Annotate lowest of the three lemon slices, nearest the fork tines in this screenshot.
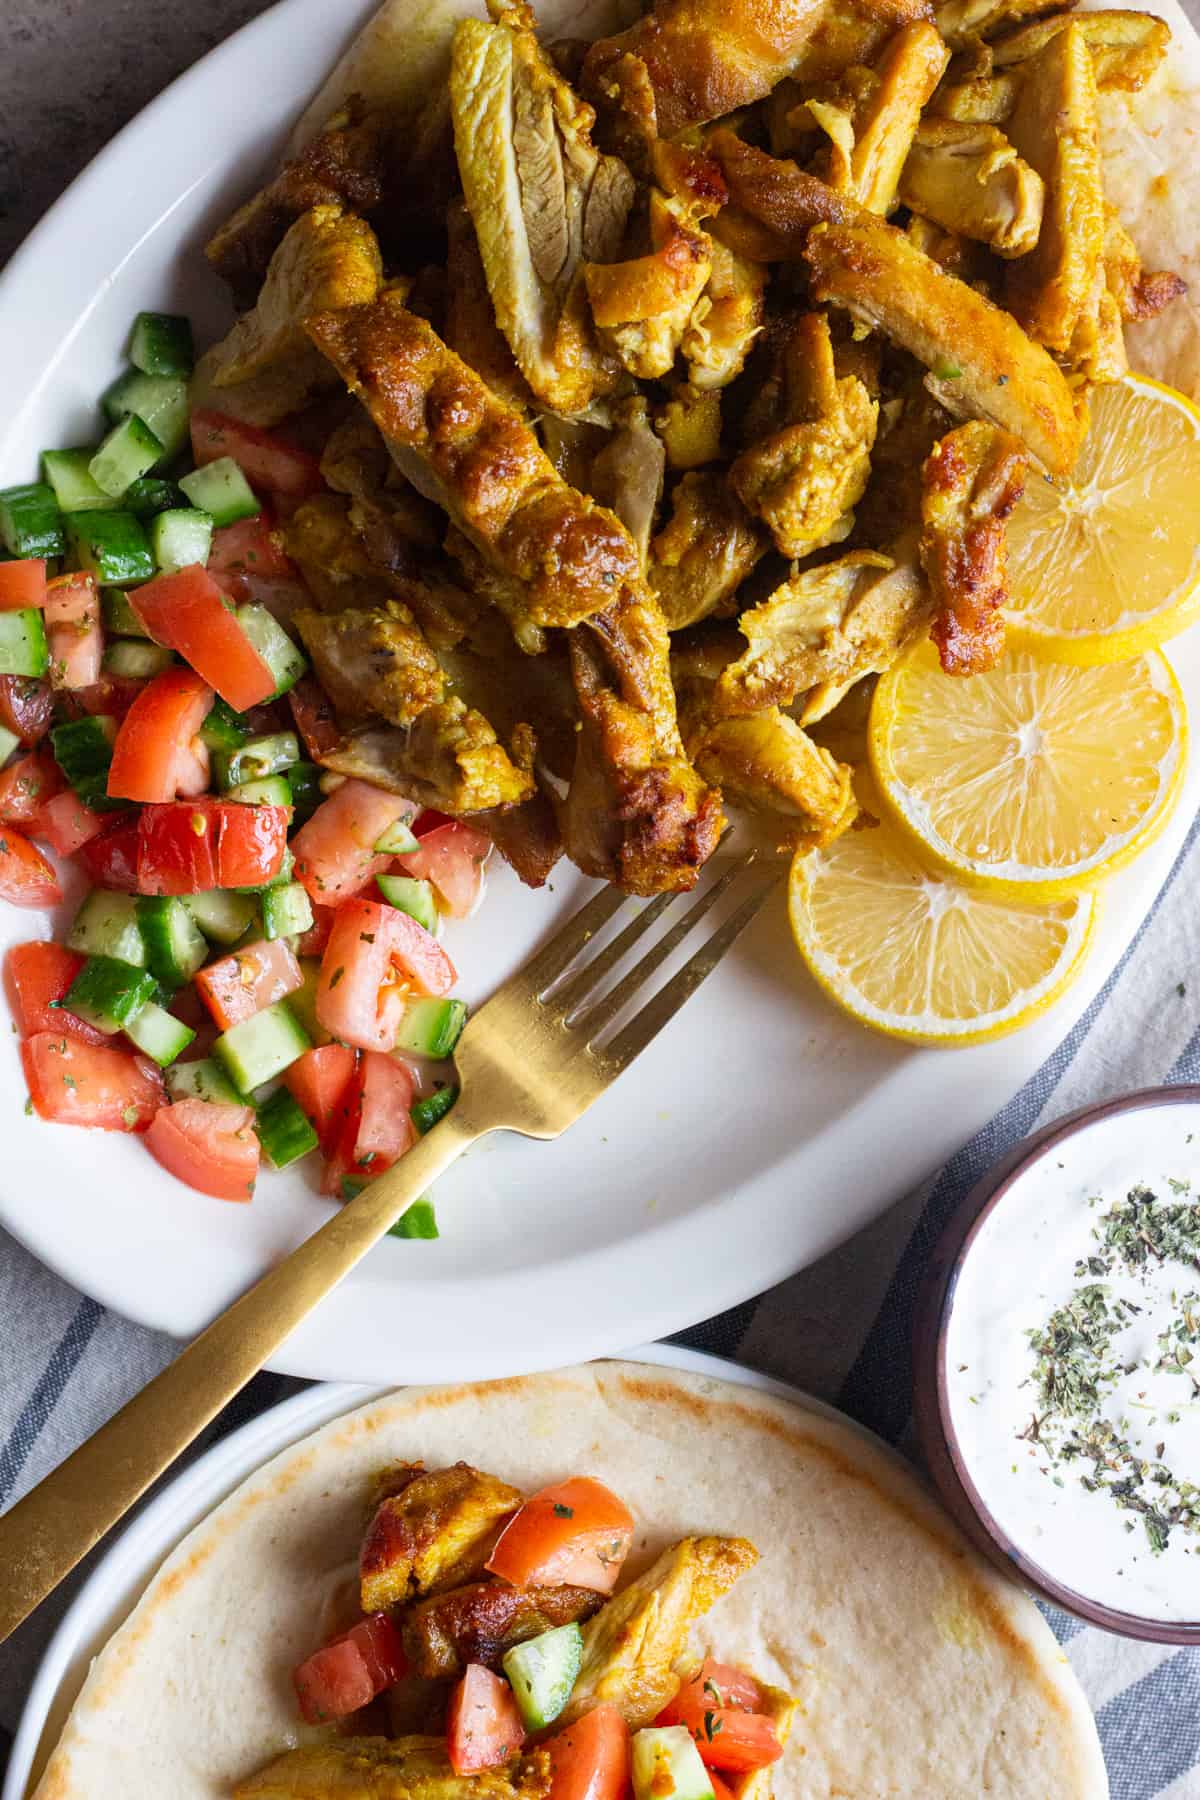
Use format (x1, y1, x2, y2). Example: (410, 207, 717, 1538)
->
(788, 823, 1096, 1044)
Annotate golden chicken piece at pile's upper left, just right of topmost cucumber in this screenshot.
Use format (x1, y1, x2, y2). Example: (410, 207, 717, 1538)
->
(193, 205, 383, 425)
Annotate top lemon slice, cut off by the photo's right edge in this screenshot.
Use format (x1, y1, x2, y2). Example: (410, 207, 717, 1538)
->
(1006, 374, 1200, 664)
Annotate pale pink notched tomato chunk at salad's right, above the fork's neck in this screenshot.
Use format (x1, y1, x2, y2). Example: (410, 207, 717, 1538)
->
(317, 900, 457, 1051)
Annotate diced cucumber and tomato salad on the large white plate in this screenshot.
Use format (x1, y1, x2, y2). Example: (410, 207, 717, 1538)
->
(0, 313, 491, 1237)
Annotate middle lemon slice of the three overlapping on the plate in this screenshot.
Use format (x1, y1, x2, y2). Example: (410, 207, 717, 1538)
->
(869, 641, 1187, 900)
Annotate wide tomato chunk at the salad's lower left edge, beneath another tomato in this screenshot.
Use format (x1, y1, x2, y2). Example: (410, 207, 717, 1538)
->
(22, 1030, 164, 1130)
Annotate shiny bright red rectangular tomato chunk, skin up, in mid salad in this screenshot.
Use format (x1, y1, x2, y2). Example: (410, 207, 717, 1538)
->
(137, 797, 290, 895)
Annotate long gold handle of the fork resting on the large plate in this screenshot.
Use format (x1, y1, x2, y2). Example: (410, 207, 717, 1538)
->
(0, 1100, 482, 1642)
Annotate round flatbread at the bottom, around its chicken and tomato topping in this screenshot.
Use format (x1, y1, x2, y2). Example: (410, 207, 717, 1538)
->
(36, 1363, 1108, 1800)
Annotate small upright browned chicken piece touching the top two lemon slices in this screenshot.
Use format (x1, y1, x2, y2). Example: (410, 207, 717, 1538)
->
(921, 419, 1025, 675)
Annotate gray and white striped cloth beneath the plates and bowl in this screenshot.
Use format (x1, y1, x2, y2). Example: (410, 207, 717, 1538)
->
(0, 821, 1200, 1800)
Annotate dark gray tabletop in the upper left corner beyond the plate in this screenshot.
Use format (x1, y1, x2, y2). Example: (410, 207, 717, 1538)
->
(0, 0, 270, 265)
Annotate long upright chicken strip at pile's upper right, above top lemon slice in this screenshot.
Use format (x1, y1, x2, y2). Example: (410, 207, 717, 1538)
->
(1004, 23, 1105, 351)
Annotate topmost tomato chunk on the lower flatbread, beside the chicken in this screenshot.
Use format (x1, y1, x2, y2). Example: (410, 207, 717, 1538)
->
(488, 1474, 633, 1593)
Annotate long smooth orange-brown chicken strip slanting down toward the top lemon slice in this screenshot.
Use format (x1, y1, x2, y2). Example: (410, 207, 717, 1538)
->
(804, 214, 1083, 475)
